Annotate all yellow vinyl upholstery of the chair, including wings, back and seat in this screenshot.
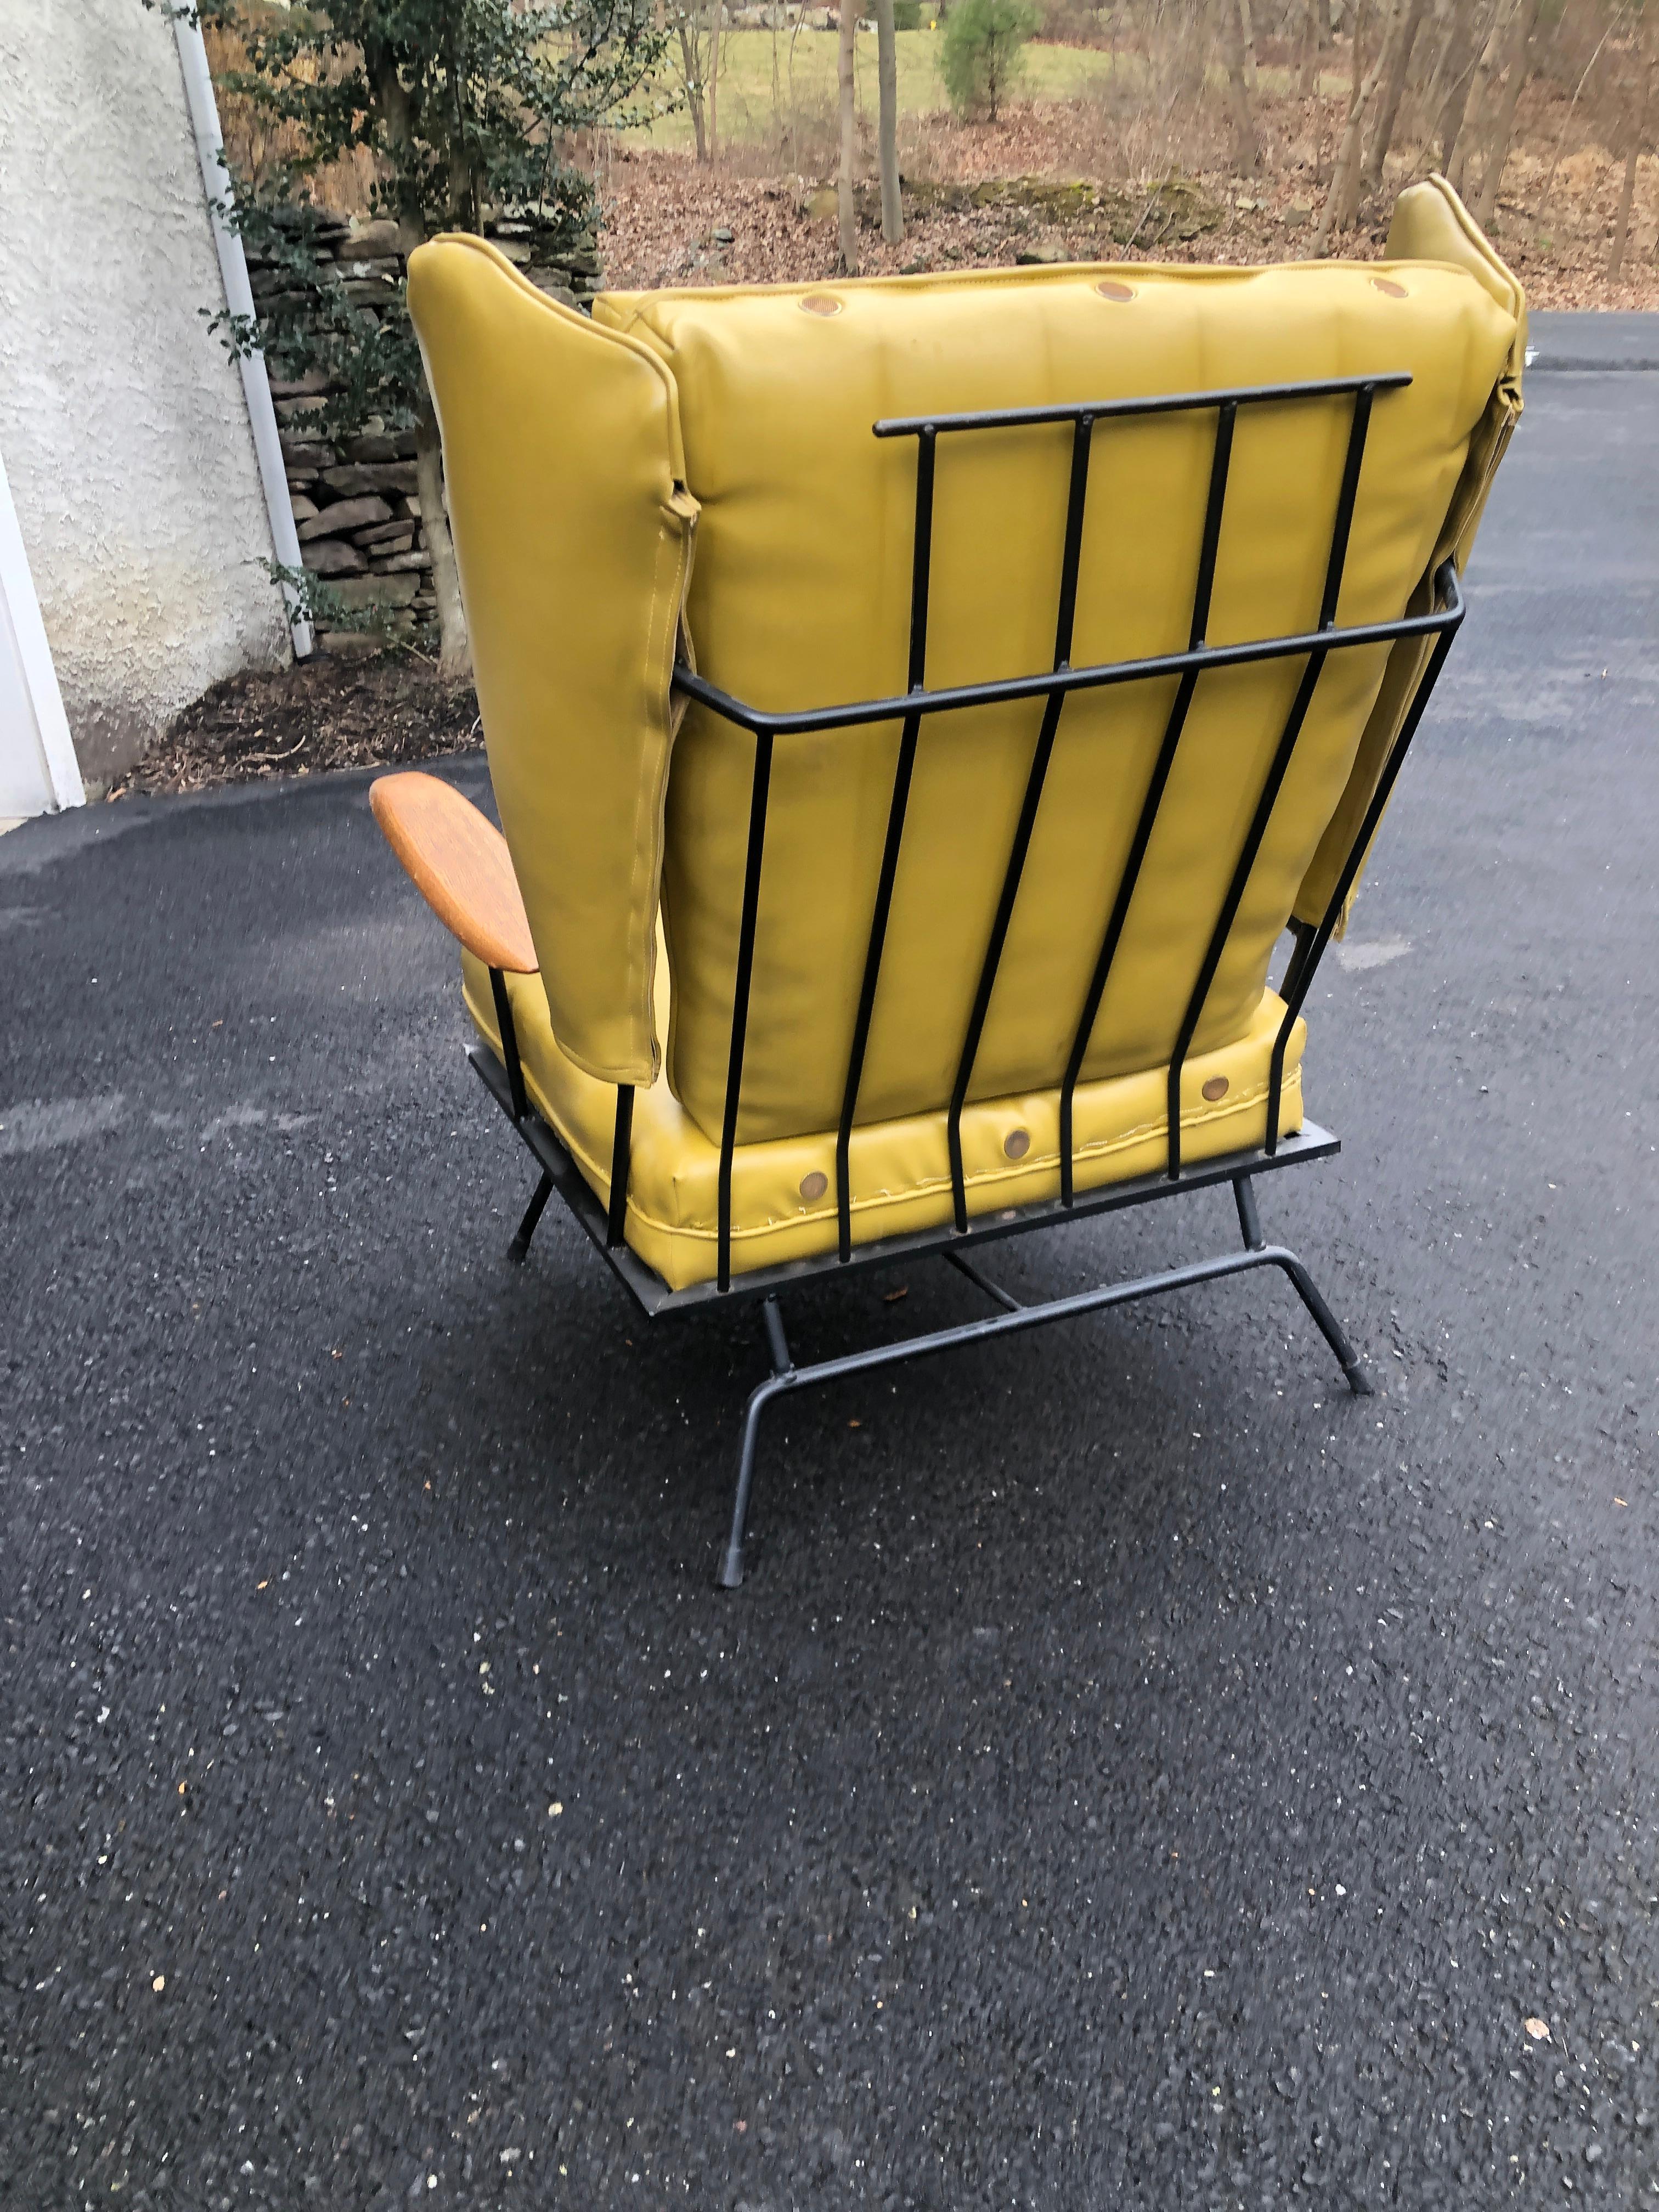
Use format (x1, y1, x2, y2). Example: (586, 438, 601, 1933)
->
(409, 184, 1524, 1288)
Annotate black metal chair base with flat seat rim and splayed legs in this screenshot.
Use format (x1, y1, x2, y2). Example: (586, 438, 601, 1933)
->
(467, 1044, 1372, 1590)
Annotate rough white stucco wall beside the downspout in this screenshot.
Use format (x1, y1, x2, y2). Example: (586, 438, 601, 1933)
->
(0, 0, 290, 778)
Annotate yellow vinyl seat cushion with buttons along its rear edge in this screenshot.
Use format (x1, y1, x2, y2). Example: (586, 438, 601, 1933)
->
(460, 953, 1305, 1290)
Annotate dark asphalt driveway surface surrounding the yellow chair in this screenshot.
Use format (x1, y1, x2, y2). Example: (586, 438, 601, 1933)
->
(0, 354, 1659, 2212)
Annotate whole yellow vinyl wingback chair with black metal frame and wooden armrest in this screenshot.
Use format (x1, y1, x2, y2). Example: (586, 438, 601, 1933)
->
(374, 179, 1526, 1586)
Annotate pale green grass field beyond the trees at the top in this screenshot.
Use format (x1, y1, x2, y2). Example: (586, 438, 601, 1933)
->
(630, 31, 1113, 150)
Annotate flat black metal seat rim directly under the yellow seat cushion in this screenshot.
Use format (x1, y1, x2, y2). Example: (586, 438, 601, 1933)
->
(467, 1042, 1342, 1321)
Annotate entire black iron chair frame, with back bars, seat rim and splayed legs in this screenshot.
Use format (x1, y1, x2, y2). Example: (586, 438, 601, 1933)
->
(469, 371, 1464, 1588)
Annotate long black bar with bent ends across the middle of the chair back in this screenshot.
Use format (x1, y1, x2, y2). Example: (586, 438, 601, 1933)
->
(675, 589, 1464, 737)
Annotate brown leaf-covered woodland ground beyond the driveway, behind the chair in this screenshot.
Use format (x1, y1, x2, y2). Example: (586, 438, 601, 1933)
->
(595, 50, 1659, 307)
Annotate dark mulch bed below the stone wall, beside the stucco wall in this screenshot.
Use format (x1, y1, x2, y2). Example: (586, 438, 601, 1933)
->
(111, 652, 480, 799)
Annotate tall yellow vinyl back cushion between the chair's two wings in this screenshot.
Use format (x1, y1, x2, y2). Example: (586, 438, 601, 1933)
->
(595, 211, 1517, 1142)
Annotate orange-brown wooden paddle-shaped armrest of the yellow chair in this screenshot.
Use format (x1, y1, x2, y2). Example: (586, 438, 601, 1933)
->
(369, 770, 538, 975)
